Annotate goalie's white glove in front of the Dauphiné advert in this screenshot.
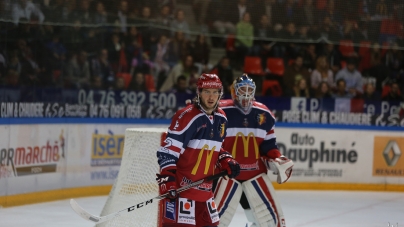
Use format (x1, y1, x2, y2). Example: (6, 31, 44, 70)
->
(261, 155, 294, 184)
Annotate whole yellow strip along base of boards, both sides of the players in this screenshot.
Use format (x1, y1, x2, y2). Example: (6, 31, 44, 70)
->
(0, 182, 404, 207)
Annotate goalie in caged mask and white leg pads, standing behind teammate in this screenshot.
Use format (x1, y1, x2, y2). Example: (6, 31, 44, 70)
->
(214, 74, 293, 227)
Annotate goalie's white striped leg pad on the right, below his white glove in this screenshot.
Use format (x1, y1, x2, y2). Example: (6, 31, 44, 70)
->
(242, 173, 286, 227)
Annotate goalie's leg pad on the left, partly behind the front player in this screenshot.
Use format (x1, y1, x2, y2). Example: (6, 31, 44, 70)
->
(214, 178, 243, 227)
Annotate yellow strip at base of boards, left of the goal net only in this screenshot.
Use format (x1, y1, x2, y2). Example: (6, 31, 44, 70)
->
(0, 185, 112, 207)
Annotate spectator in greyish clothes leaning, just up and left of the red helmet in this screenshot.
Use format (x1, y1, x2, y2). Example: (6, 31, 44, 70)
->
(159, 55, 198, 92)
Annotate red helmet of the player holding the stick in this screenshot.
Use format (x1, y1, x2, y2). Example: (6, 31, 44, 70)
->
(195, 73, 223, 112)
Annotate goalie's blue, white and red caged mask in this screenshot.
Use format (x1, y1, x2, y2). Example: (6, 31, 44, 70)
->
(231, 73, 256, 114)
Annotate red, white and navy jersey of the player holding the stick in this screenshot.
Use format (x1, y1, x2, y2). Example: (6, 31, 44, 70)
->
(157, 105, 227, 201)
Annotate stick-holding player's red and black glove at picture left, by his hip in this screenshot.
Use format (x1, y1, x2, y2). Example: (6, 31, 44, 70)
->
(156, 170, 179, 199)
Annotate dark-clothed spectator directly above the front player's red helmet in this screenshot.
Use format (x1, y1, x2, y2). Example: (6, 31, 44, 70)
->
(191, 34, 210, 74)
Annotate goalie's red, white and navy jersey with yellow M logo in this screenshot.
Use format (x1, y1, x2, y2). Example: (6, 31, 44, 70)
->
(219, 100, 280, 180)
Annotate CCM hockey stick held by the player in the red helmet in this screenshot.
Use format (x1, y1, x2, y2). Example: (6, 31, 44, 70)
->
(70, 171, 227, 223)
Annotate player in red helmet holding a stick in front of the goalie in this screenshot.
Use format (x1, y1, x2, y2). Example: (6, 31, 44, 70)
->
(156, 74, 240, 227)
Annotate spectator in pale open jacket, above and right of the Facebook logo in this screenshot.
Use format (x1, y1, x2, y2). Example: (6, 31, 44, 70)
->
(311, 55, 335, 90)
